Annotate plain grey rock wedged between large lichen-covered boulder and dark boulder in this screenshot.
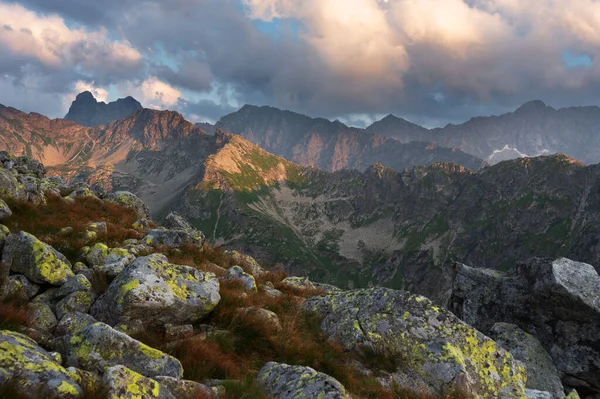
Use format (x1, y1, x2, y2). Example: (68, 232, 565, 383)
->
(490, 323, 565, 399)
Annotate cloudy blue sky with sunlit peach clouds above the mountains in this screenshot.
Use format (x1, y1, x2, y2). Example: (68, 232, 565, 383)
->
(0, 0, 600, 127)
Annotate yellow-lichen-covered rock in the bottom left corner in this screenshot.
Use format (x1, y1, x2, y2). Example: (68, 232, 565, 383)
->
(0, 331, 83, 399)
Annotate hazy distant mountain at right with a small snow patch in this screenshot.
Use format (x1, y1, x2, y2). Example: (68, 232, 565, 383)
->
(366, 101, 600, 164)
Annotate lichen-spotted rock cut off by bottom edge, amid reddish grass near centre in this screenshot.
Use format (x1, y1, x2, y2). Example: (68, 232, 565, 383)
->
(256, 362, 350, 399)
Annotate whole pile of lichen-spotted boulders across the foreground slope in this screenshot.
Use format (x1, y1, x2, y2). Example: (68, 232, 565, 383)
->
(0, 153, 600, 399)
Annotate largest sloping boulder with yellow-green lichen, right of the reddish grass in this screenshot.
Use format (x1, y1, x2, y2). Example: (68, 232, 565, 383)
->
(303, 288, 527, 398)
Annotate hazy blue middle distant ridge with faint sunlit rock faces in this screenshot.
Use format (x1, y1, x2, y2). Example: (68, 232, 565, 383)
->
(216, 105, 484, 171)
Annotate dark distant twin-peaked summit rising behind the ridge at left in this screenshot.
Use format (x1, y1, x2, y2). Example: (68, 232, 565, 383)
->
(65, 91, 143, 127)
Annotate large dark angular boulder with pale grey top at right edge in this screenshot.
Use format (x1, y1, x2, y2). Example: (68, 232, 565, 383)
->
(449, 258, 600, 395)
